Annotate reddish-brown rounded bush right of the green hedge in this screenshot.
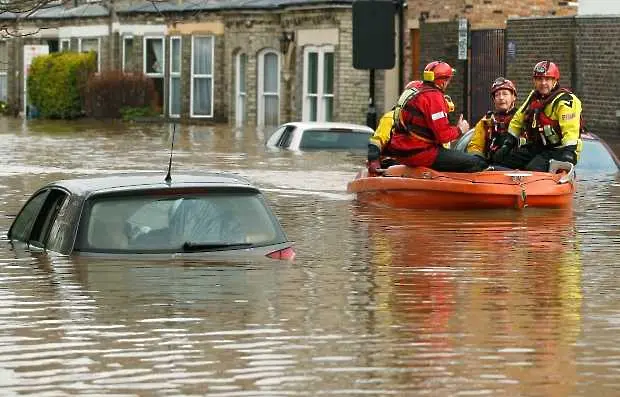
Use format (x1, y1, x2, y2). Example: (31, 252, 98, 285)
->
(84, 70, 157, 119)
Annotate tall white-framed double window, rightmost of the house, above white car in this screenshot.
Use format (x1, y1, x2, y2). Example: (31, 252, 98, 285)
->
(302, 46, 334, 121)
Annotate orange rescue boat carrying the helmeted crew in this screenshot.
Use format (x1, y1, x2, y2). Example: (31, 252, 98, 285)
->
(347, 161, 575, 209)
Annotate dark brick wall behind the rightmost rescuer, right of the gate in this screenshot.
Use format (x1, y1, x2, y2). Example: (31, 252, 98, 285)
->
(506, 17, 620, 135)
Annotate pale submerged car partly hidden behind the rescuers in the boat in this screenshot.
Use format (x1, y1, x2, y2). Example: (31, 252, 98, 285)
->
(453, 129, 620, 173)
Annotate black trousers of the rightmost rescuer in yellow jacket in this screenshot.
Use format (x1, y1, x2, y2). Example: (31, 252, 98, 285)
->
(495, 145, 577, 172)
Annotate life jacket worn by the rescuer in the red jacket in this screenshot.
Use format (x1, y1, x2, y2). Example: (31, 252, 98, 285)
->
(393, 83, 440, 143)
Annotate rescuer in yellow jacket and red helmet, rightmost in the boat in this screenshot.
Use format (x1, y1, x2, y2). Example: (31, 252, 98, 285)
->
(494, 61, 584, 171)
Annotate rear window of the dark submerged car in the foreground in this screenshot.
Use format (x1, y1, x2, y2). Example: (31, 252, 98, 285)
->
(75, 192, 286, 253)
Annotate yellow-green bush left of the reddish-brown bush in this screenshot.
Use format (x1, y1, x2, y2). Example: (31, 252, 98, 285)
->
(28, 52, 97, 119)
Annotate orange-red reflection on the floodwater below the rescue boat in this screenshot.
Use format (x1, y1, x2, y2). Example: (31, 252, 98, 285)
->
(355, 207, 582, 396)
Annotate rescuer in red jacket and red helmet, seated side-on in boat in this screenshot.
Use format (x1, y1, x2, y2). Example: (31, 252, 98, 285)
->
(368, 61, 487, 172)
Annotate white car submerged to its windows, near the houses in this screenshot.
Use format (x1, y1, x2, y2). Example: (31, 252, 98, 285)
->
(266, 121, 374, 151)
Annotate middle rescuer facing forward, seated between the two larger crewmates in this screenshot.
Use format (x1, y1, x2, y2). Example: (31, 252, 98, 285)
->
(467, 77, 517, 162)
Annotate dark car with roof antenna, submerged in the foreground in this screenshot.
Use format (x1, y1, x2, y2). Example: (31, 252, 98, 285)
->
(7, 173, 295, 259)
